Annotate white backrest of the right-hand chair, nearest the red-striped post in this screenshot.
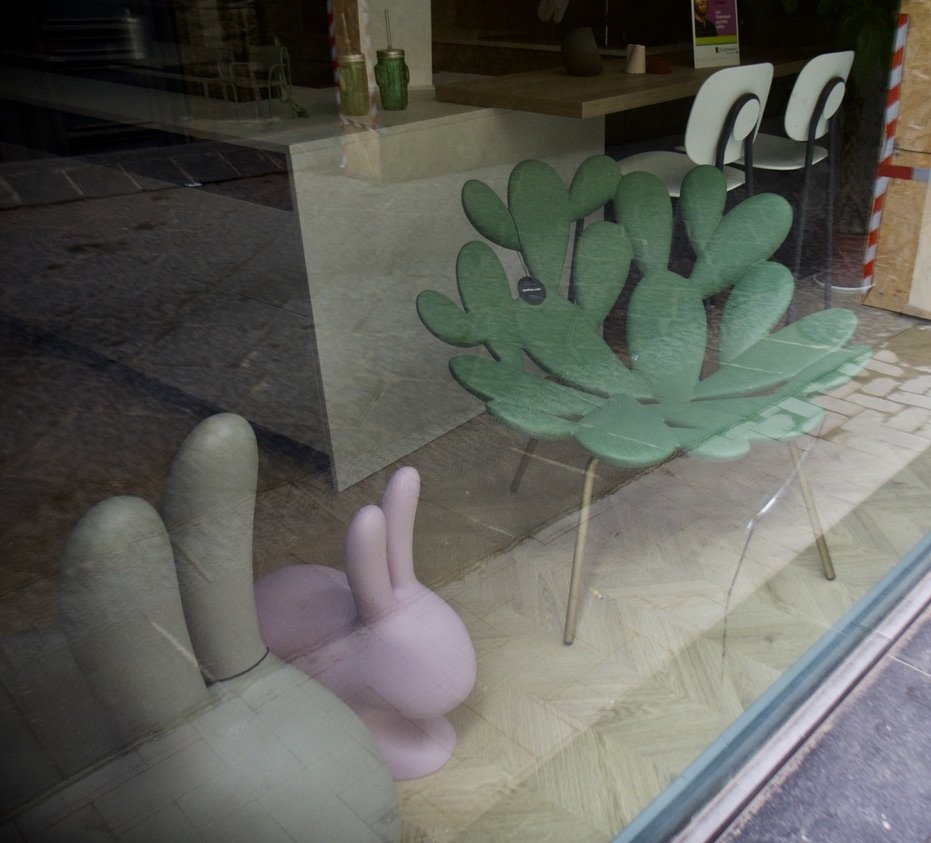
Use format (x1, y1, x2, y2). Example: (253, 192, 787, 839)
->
(785, 50, 853, 141)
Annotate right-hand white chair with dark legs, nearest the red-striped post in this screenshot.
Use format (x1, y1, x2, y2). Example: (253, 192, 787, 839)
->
(747, 50, 853, 306)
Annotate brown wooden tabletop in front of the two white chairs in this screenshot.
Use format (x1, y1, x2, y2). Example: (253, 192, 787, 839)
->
(436, 51, 810, 118)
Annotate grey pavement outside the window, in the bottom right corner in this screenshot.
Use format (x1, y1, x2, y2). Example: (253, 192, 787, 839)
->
(718, 592, 931, 843)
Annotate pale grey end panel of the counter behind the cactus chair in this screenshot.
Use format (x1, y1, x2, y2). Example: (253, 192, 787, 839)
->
(288, 91, 604, 489)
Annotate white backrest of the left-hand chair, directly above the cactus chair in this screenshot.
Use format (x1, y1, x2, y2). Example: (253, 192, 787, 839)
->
(685, 62, 773, 165)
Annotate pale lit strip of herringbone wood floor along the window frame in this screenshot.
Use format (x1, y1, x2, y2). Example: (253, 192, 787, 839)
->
(399, 318, 931, 843)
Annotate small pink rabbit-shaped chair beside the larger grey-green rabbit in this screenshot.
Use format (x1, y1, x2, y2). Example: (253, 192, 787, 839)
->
(255, 468, 475, 779)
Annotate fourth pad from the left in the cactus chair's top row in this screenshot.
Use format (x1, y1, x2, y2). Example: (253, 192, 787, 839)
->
(614, 173, 672, 275)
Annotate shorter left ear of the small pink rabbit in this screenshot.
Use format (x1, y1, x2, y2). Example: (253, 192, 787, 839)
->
(344, 505, 395, 623)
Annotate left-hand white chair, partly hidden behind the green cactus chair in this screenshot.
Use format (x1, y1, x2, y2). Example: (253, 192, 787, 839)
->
(618, 62, 773, 197)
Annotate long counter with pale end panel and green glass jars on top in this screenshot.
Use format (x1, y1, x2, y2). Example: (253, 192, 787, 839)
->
(0, 62, 604, 489)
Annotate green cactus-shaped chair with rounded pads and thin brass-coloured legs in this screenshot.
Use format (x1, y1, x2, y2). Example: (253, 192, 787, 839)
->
(417, 155, 870, 644)
